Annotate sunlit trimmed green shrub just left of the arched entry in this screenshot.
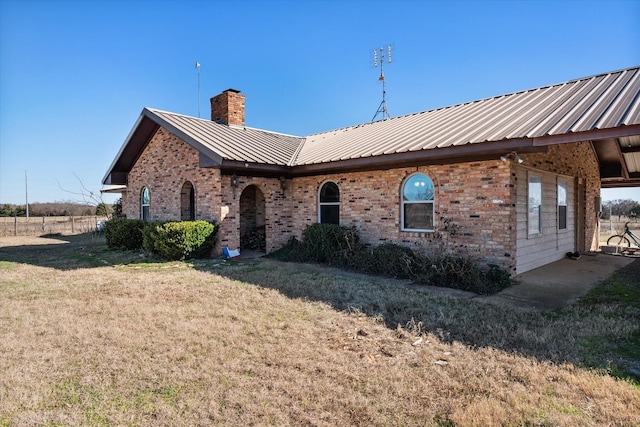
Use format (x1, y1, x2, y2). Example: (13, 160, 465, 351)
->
(143, 221, 218, 260)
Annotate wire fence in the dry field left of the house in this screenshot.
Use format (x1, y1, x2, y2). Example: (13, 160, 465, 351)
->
(0, 215, 107, 237)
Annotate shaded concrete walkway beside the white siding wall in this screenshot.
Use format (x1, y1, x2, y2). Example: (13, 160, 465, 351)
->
(475, 252, 637, 311)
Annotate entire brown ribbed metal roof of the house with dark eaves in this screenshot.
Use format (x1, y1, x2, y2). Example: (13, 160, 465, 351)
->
(103, 67, 640, 187)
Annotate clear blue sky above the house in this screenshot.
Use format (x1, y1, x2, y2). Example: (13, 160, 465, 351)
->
(0, 0, 640, 204)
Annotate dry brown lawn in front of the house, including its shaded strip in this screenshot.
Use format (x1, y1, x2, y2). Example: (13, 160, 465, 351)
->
(0, 237, 640, 426)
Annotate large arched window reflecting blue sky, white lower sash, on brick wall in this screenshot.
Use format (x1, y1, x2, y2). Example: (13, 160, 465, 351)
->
(401, 173, 434, 231)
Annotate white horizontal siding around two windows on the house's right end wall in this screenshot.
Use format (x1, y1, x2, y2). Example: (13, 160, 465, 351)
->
(516, 167, 575, 274)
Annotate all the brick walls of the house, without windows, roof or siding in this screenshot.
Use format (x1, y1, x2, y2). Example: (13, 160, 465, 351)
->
(123, 128, 600, 271)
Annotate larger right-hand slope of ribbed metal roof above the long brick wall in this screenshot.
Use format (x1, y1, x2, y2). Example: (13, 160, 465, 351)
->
(295, 67, 640, 165)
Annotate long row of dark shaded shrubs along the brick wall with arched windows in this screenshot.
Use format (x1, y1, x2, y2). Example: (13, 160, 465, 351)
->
(269, 224, 513, 295)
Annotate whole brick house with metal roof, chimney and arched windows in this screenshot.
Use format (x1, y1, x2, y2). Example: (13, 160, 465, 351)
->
(103, 67, 640, 275)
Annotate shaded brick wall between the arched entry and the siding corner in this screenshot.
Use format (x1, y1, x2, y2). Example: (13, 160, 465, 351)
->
(278, 161, 515, 267)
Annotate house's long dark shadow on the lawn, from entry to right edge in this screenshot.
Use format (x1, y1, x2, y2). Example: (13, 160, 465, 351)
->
(202, 254, 640, 385)
